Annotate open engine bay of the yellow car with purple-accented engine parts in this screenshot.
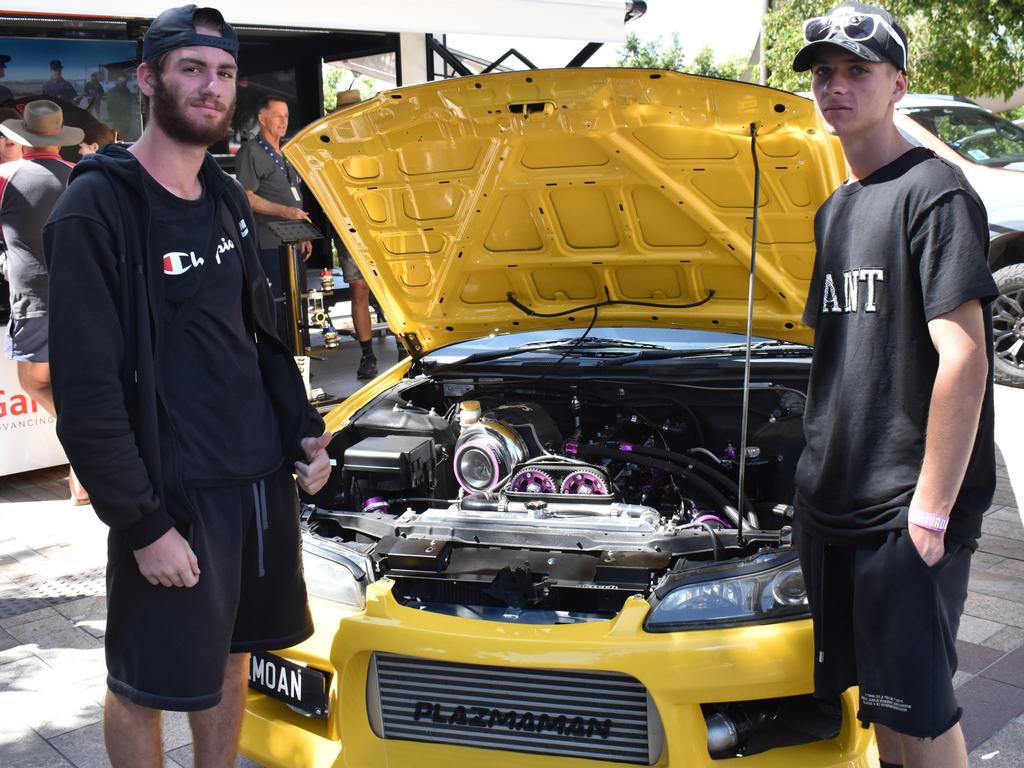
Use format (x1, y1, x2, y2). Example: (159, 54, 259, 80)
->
(306, 366, 806, 623)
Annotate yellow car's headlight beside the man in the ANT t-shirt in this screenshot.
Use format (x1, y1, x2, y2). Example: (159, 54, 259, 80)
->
(644, 551, 810, 632)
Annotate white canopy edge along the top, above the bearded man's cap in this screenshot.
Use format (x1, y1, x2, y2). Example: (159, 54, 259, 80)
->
(3, 0, 626, 42)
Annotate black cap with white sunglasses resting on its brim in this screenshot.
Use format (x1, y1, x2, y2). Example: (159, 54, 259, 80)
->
(793, 3, 906, 72)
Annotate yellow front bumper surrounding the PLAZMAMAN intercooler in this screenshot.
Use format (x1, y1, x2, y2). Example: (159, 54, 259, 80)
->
(242, 580, 874, 768)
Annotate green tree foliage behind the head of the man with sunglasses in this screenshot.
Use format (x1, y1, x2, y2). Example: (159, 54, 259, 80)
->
(764, 0, 1024, 96)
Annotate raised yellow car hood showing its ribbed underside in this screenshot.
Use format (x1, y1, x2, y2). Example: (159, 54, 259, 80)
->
(285, 69, 844, 354)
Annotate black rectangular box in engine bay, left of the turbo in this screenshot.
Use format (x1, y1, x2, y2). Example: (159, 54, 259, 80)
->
(344, 435, 434, 490)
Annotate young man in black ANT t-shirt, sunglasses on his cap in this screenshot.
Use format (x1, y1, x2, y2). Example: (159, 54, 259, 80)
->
(794, 3, 996, 768)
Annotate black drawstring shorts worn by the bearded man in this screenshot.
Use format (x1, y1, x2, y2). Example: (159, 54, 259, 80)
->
(105, 466, 312, 712)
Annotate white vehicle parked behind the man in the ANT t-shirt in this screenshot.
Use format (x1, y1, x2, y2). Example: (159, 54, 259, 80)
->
(896, 94, 1024, 387)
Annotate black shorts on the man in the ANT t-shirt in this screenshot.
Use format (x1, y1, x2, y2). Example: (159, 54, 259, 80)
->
(796, 528, 972, 738)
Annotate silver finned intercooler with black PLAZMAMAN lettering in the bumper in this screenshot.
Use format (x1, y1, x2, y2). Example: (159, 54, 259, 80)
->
(367, 653, 664, 765)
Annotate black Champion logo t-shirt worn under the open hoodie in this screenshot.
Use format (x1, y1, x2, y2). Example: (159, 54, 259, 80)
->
(143, 174, 283, 486)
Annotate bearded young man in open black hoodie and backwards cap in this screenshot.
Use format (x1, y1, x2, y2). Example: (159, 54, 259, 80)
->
(45, 5, 331, 768)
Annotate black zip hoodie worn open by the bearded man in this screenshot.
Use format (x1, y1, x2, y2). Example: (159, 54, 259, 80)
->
(43, 144, 324, 549)
